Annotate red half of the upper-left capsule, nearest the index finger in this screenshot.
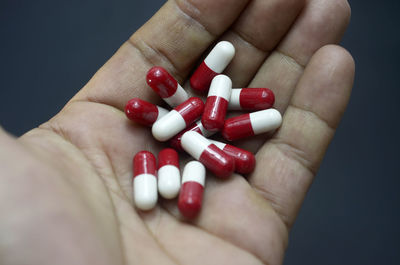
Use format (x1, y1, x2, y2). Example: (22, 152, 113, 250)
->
(146, 66, 178, 98)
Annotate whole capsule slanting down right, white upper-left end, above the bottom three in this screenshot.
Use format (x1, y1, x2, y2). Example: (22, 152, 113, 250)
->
(181, 131, 235, 178)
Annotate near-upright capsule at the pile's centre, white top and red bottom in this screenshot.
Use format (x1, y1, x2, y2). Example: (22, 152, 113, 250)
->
(201, 75, 232, 132)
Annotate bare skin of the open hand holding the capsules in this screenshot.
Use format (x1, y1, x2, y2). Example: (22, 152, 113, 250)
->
(0, 0, 354, 265)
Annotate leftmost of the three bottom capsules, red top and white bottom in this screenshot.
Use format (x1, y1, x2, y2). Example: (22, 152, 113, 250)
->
(133, 151, 158, 211)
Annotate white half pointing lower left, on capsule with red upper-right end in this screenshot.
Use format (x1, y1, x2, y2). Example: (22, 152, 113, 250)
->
(151, 110, 186, 142)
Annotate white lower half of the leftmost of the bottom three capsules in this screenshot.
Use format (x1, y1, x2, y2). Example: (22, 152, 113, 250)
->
(133, 174, 158, 211)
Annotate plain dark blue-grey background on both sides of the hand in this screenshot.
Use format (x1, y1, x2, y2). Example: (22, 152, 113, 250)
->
(0, 0, 400, 265)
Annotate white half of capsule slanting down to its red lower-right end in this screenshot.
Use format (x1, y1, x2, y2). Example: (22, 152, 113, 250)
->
(181, 131, 211, 160)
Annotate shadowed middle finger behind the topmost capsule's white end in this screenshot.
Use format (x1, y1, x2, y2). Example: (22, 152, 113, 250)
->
(221, 0, 304, 87)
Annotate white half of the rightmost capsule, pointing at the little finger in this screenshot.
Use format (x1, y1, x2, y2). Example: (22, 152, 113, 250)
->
(250, 109, 282, 135)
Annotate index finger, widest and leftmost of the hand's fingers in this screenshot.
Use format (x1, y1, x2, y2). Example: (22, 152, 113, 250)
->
(74, 0, 248, 109)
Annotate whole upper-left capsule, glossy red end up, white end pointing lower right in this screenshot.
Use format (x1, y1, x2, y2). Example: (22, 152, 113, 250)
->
(146, 66, 189, 108)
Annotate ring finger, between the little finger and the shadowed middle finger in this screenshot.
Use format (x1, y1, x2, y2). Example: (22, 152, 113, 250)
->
(250, 0, 350, 112)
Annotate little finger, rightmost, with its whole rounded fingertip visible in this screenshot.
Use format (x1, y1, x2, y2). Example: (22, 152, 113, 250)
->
(249, 45, 354, 227)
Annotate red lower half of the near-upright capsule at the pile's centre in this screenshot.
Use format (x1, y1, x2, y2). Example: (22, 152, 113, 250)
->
(201, 96, 228, 132)
